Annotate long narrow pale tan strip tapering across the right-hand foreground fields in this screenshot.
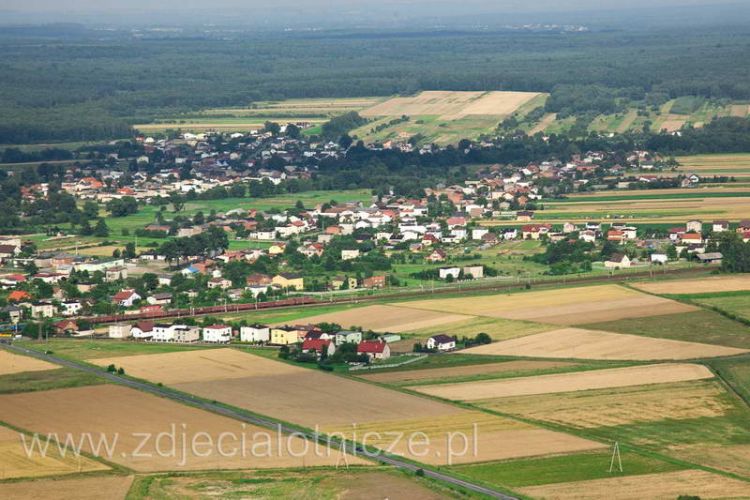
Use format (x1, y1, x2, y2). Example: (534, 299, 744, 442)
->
(413, 363, 714, 401)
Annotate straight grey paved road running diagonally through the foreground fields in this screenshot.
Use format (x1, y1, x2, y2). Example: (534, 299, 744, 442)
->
(0, 344, 517, 500)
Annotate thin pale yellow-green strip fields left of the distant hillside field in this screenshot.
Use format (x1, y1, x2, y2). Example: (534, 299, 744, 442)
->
(135, 97, 384, 133)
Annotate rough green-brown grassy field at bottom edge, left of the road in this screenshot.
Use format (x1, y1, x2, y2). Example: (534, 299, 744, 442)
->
(131, 468, 460, 500)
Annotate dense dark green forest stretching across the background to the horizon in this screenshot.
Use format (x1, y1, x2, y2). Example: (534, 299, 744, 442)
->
(0, 27, 750, 144)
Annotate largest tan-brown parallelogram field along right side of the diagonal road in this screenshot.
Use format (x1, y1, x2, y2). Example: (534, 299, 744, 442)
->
(91, 349, 602, 464)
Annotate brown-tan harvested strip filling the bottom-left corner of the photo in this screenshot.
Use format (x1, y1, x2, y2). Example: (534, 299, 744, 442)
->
(0, 476, 133, 500)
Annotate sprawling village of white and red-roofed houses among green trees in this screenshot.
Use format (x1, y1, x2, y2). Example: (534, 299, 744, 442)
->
(0, 129, 750, 346)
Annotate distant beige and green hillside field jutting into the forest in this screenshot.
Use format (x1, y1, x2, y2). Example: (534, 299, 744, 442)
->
(350, 91, 547, 145)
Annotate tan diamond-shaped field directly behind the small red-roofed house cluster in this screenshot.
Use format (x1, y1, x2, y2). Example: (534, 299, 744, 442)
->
(280, 306, 471, 333)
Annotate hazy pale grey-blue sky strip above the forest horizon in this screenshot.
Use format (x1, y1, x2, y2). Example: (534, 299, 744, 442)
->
(0, 0, 750, 26)
